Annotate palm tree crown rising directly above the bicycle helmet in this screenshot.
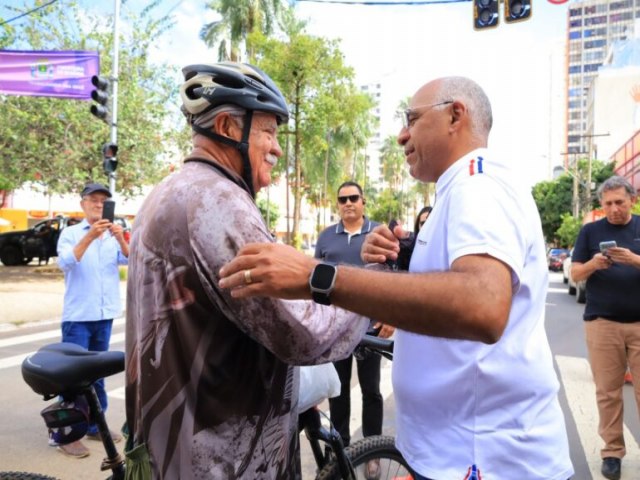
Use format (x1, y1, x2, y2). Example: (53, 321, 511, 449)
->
(200, 0, 289, 61)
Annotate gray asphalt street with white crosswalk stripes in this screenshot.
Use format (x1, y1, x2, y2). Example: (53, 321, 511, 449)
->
(0, 272, 640, 480)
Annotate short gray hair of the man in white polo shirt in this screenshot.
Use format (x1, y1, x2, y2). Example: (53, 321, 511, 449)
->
(438, 77, 493, 140)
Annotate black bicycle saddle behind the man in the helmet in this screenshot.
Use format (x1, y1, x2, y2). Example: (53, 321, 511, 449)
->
(22, 343, 124, 397)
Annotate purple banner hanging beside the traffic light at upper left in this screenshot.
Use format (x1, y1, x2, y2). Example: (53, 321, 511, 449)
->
(0, 50, 100, 100)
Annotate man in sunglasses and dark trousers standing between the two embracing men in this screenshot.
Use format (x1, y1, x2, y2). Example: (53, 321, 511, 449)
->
(315, 181, 393, 478)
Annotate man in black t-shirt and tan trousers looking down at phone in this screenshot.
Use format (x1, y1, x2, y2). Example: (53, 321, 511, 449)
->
(571, 176, 640, 480)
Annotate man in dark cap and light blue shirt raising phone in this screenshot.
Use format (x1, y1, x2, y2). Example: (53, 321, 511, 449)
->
(49, 183, 129, 458)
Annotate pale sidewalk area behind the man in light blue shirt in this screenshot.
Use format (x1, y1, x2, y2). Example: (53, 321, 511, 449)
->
(0, 263, 126, 332)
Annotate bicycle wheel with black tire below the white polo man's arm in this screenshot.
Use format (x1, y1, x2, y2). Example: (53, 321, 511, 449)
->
(316, 435, 412, 480)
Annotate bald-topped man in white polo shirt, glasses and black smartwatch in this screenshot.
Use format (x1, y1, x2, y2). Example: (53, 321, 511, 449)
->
(221, 77, 573, 480)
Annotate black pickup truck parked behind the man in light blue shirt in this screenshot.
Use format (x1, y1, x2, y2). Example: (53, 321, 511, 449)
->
(0, 216, 131, 266)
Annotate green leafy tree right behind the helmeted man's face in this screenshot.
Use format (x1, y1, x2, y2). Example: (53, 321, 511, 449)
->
(247, 18, 373, 244)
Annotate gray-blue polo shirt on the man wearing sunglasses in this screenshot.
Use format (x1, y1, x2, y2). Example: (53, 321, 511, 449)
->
(315, 217, 380, 265)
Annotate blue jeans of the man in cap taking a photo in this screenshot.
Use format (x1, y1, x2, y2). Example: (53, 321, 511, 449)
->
(62, 319, 113, 434)
